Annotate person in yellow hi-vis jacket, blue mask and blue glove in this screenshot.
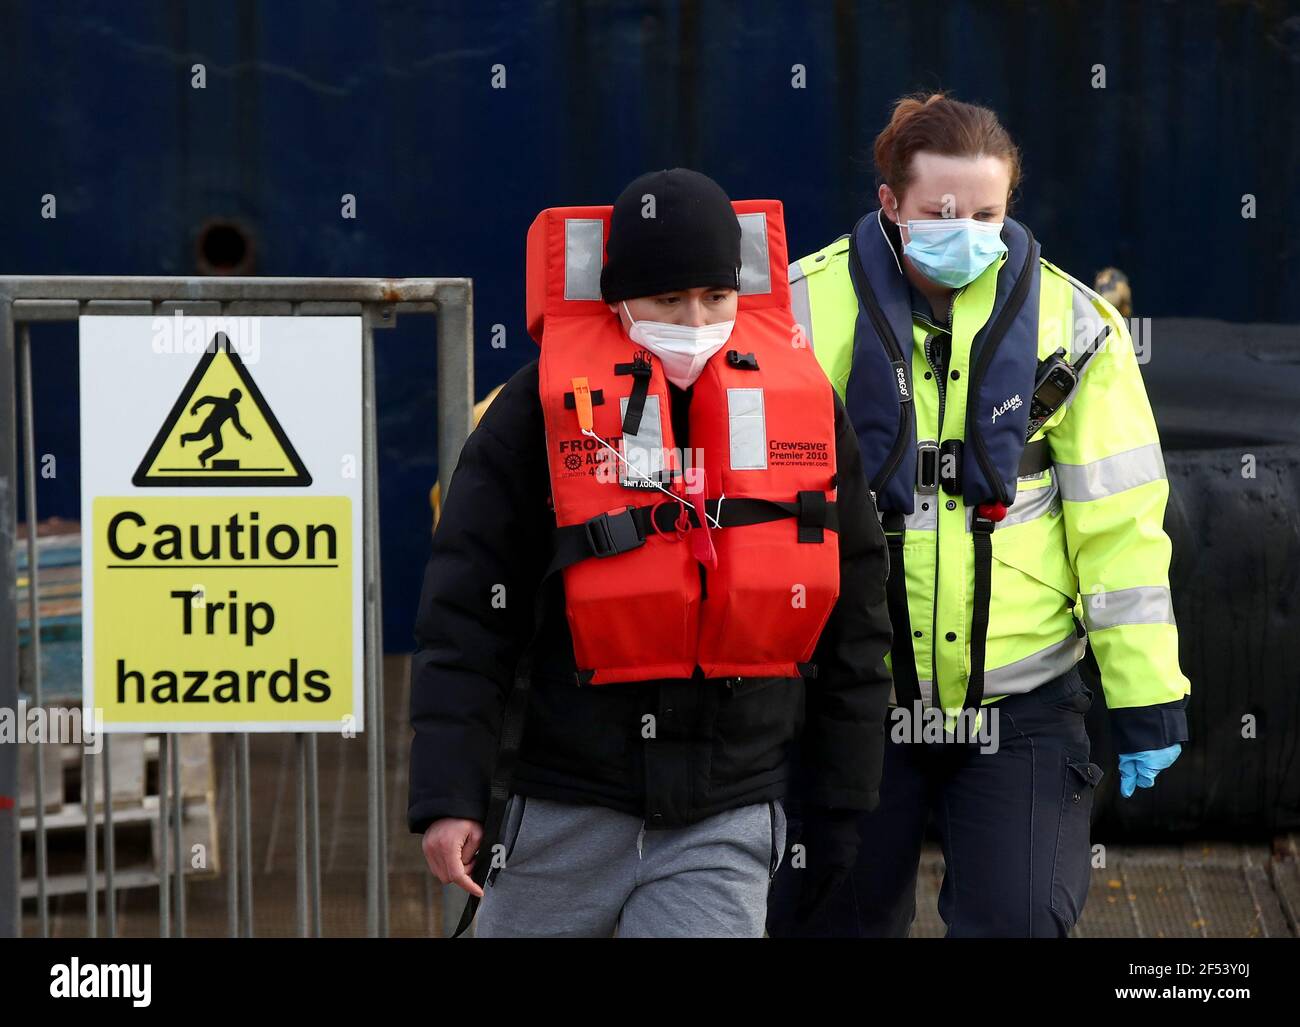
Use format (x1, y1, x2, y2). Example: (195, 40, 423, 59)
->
(771, 94, 1190, 937)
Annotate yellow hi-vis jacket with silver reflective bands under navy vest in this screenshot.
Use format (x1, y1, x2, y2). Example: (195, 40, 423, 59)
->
(789, 237, 1191, 753)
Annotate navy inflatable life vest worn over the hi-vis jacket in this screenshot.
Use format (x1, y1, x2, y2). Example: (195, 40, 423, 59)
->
(845, 211, 1041, 514)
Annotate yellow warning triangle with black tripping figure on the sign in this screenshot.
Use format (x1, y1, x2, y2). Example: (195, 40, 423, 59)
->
(131, 332, 312, 488)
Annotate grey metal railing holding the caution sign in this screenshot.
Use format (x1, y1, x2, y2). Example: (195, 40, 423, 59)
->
(0, 276, 473, 937)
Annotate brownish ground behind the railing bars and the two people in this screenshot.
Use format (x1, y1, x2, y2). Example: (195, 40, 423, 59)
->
(23, 655, 1300, 937)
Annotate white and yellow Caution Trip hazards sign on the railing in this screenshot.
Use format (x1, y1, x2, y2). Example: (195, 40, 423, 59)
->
(81, 316, 364, 732)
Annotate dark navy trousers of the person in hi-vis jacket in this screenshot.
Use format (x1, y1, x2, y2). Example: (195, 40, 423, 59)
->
(768, 670, 1101, 937)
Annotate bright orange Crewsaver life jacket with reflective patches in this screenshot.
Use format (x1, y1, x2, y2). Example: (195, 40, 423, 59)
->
(528, 200, 840, 685)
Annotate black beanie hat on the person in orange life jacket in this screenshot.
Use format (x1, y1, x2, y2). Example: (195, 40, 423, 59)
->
(601, 168, 740, 303)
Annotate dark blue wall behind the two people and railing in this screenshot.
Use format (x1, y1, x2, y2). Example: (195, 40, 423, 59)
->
(0, 0, 1300, 650)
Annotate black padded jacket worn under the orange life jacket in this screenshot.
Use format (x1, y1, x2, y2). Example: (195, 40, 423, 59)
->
(407, 360, 891, 833)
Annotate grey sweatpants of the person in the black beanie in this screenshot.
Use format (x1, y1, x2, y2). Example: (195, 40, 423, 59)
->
(477, 796, 785, 937)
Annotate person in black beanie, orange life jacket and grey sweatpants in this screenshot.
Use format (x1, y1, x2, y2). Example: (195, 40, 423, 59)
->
(407, 169, 889, 937)
